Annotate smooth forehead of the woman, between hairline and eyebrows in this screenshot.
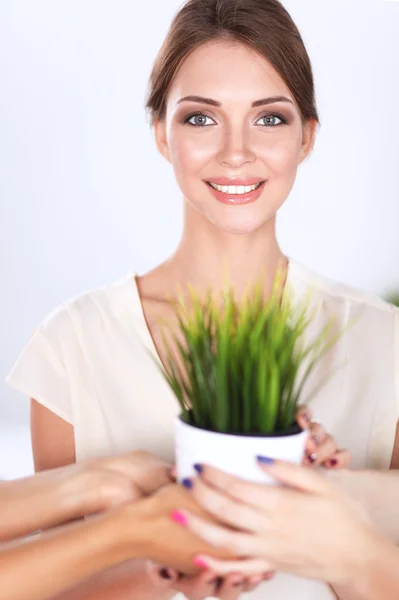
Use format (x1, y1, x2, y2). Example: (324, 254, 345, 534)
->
(168, 41, 294, 104)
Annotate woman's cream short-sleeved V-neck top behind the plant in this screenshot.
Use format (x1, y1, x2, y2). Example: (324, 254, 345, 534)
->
(7, 260, 399, 600)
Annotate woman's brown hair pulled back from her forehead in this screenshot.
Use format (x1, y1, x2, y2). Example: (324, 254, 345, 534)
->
(146, 0, 319, 122)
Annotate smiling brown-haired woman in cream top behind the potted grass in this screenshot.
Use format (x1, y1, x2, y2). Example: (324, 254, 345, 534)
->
(8, 0, 398, 600)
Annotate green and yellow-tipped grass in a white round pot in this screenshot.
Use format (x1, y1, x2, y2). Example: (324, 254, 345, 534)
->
(158, 277, 337, 482)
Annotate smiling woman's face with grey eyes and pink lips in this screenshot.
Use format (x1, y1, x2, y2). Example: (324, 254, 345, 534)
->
(155, 41, 316, 234)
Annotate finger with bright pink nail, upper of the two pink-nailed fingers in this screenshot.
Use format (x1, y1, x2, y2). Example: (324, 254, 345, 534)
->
(172, 510, 259, 566)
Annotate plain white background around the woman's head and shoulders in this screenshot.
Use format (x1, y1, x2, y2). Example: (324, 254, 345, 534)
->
(0, 0, 399, 477)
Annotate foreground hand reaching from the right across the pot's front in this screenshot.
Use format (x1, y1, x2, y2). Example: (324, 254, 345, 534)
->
(170, 461, 380, 585)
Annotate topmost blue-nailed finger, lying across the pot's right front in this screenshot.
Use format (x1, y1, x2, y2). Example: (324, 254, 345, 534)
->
(255, 457, 333, 495)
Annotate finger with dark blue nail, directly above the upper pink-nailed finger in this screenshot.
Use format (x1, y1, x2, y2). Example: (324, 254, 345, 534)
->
(191, 478, 267, 532)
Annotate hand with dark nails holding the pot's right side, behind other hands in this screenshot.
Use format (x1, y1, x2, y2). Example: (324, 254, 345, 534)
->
(296, 406, 351, 469)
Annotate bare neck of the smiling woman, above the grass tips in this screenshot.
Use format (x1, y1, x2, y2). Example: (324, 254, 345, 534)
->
(168, 206, 287, 297)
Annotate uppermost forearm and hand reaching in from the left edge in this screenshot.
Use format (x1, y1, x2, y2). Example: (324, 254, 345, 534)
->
(0, 451, 172, 540)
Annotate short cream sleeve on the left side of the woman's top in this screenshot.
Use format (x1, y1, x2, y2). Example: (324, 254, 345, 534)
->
(6, 311, 73, 424)
